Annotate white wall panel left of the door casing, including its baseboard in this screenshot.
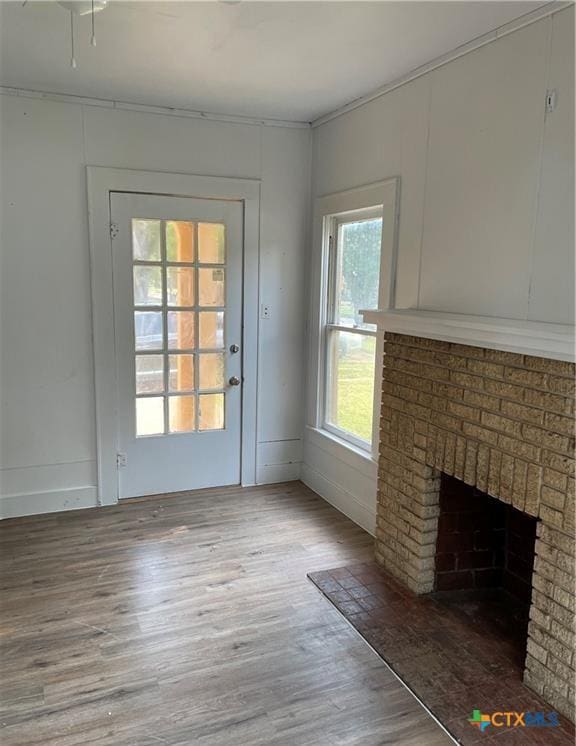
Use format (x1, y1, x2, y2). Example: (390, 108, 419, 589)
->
(0, 97, 96, 515)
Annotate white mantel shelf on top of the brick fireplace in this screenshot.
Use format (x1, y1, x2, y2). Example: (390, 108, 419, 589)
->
(361, 309, 575, 362)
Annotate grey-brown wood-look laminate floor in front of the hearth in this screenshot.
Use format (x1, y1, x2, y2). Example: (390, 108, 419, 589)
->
(0, 482, 452, 746)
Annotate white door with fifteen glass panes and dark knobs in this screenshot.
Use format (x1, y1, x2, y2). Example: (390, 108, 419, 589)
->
(110, 192, 243, 498)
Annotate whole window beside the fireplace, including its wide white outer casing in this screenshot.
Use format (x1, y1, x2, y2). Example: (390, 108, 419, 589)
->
(307, 177, 400, 460)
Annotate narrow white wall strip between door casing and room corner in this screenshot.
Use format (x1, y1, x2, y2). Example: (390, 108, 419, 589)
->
(256, 127, 310, 482)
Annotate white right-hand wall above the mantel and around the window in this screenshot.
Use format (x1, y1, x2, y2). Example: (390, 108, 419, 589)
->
(302, 8, 574, 528)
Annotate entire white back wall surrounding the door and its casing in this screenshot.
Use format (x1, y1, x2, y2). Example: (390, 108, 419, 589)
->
(0, 95, 310, 516)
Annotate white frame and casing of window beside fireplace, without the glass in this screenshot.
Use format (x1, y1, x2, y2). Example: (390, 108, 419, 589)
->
(307, 177, 399, 461)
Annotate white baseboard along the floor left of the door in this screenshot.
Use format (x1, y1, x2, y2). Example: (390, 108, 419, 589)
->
(0, 487, 98, 520)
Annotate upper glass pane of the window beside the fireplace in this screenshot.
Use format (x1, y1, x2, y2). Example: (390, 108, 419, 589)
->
(335, 218, 382, 328)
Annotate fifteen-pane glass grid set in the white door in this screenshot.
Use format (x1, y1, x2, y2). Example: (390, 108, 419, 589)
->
(132, 218, 226, 437)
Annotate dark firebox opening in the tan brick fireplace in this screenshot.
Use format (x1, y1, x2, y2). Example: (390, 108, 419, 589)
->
(433, 474, 537, 667)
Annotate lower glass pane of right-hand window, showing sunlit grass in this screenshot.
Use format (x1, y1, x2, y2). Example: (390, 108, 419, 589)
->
(326, 331, 376, 442)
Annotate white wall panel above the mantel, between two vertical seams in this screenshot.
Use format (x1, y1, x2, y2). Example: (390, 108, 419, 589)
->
(418, 20, 550, 319)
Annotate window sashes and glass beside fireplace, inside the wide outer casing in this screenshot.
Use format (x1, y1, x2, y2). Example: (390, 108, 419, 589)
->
(323, 205, 382, 450)
